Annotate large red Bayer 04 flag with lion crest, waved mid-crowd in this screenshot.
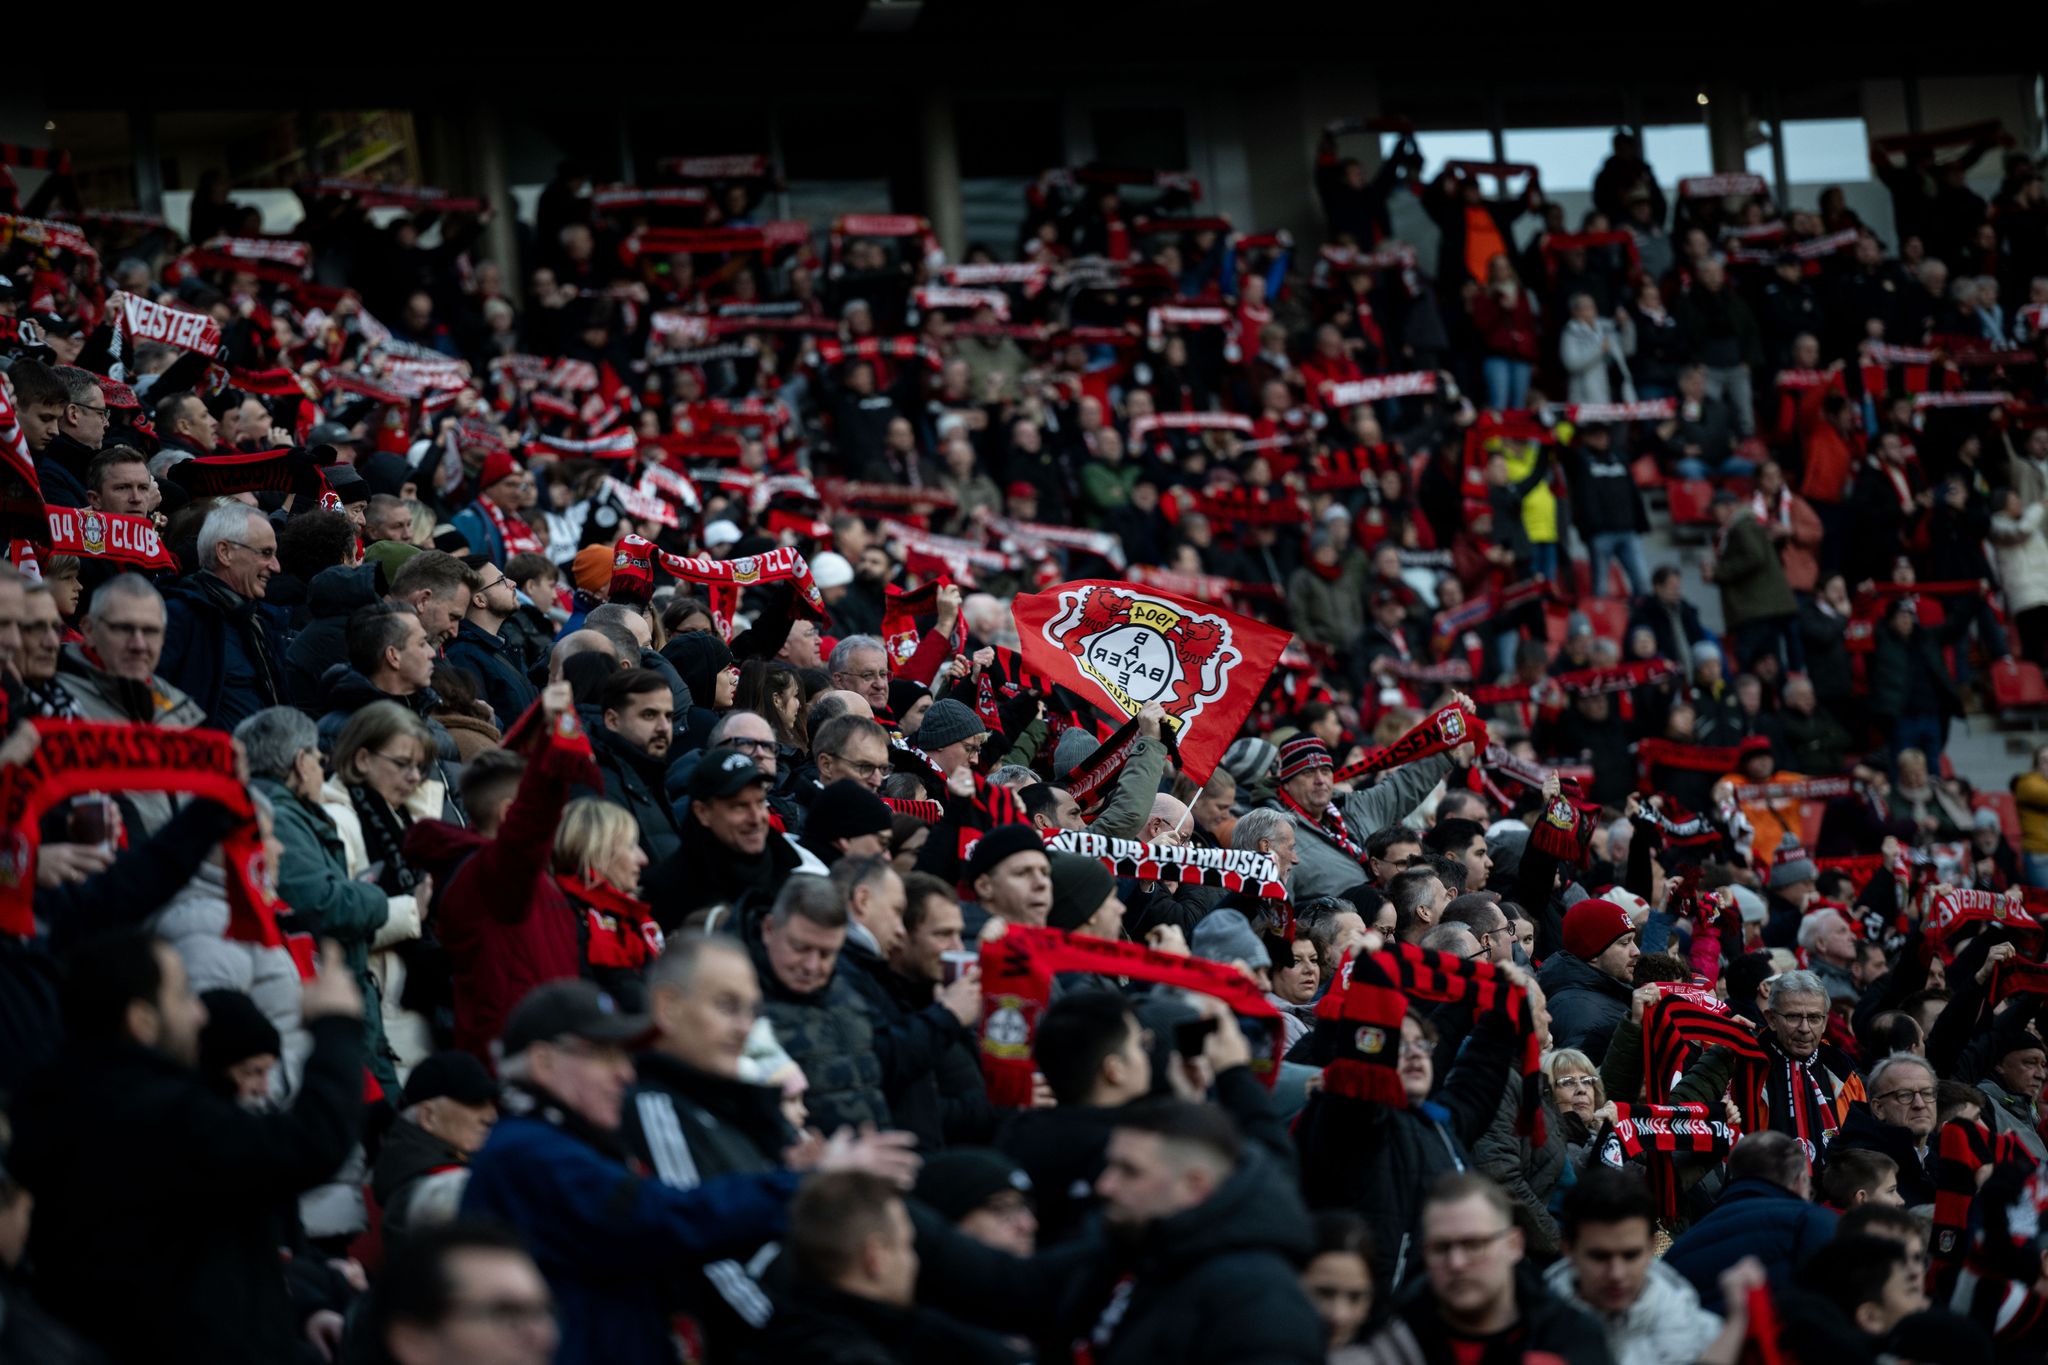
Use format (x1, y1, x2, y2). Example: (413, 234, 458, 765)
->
(1014, 579, 1292, 782)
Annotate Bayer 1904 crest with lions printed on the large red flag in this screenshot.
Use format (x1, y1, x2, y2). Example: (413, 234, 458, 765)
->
(1044, 587, 1243, 733)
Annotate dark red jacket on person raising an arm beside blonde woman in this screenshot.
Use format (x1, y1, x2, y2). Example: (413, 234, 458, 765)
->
(406, 761, 584, 1066)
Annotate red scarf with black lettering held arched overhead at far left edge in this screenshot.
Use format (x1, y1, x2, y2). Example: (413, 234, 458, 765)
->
(0, 720, 289, 948)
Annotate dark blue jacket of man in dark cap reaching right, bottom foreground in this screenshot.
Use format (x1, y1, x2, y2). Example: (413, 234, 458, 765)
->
(463, 1087, 797, 1365)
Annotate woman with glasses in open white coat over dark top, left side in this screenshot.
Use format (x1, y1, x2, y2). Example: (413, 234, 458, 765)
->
(319, 702, 446, 1078)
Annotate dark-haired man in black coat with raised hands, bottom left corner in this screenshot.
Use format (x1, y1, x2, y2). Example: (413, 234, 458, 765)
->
(8, 933, 362, 1365)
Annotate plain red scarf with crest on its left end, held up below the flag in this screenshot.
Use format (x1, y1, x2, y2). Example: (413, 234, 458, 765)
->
(981, 925, 1286, 1109)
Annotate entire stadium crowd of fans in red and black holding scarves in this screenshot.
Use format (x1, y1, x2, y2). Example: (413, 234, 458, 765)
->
(0, 121, 2048, 1365)
